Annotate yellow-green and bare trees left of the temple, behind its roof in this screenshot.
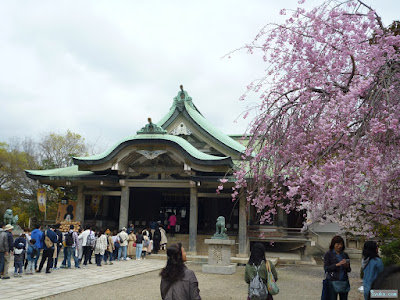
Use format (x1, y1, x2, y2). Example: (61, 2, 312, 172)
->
(0, 130, 89, 226)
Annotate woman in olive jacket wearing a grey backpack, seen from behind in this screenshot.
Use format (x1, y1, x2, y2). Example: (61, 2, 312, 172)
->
(244, 243, 278, 300)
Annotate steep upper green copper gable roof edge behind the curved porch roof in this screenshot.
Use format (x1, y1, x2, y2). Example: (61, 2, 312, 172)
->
(157, 90, 246, 153)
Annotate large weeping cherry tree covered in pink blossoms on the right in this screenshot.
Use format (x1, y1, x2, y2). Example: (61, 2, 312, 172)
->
(233, 1, 400, 235)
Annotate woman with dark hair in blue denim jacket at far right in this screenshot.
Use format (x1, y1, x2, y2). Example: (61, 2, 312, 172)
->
(361, 241, 384, 300)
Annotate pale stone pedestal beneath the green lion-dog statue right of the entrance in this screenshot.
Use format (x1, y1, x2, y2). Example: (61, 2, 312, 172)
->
(203, 239, 236, 275)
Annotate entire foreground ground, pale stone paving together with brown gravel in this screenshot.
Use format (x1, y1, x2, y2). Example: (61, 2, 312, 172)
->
(0, 255, 363, 300)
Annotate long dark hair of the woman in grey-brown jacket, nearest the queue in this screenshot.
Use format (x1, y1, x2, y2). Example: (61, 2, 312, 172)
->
(160, 243, 185, 283)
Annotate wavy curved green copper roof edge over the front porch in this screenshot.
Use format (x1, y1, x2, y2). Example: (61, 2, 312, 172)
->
(73, 133, 231, 164)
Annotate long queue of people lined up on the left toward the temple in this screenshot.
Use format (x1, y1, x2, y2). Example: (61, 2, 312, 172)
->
(0, 222, 168, 279)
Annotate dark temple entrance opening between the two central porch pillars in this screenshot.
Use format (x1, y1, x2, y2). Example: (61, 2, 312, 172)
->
(129, 188, 190, 234)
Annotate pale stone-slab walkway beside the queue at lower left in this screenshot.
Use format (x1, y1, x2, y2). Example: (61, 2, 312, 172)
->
(0, 259, 165, 300)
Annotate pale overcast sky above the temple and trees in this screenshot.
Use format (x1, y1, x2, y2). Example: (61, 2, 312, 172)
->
(0, 0, 400, 150)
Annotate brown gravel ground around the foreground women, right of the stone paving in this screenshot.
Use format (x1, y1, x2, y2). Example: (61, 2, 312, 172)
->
(44, 261, 363, 300)
